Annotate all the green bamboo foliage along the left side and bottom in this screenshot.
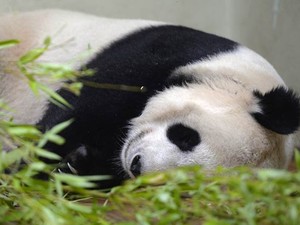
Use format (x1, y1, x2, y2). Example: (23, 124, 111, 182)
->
(0, 38, 300, 225)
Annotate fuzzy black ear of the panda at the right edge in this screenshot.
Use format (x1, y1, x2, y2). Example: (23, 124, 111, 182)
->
(252, 86, 300, 134)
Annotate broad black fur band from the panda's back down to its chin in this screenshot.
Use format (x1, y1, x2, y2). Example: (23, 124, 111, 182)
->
(38, 26, 237, 184)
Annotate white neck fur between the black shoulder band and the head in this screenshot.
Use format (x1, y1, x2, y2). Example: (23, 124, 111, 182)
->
(174, 46, 284, 93)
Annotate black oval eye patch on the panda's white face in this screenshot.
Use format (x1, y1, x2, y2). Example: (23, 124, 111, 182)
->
(167, 123, 201, 152)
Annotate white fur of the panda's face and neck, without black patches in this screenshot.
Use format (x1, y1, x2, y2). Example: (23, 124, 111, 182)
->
(121, 47, 293, 176)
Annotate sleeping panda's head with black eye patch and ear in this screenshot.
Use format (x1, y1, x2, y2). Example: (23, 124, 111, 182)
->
(121, 79, 300, 177)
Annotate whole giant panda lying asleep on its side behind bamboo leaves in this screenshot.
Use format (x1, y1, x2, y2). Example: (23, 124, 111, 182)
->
(0, 9, 300, 186)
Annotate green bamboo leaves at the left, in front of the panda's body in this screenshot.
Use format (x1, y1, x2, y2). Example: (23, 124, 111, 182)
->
(0, 38, 108, 224)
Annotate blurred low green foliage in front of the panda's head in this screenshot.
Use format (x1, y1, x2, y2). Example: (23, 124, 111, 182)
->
(106, 164, 300, 224)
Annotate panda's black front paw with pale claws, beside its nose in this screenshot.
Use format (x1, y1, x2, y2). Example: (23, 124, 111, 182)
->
(54, 126, 129, 188)
